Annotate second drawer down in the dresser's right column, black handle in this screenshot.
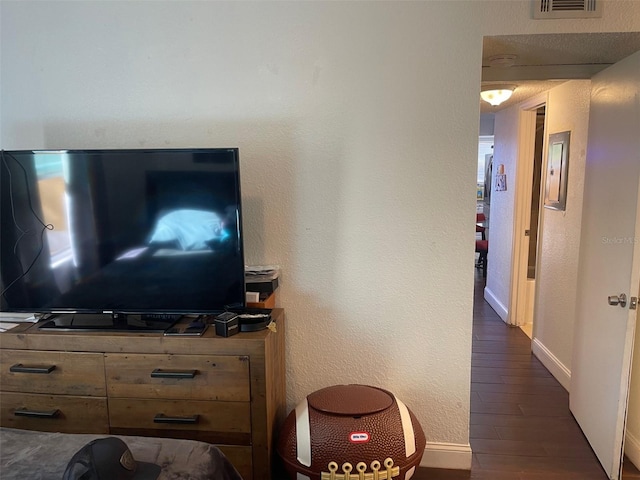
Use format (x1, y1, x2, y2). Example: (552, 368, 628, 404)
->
(109, 398, 251, 444)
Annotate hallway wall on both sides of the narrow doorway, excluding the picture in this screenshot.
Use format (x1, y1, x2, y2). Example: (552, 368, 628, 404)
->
(485, 80, 590, 389)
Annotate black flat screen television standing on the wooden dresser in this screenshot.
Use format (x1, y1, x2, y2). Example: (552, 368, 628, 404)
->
(0, 148, 245, 331)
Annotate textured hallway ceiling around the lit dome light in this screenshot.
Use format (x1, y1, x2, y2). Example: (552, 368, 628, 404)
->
(480, 32, 640, 114)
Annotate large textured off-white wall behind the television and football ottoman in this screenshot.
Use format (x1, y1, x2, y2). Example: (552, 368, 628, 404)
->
(0, 0, 640, 466)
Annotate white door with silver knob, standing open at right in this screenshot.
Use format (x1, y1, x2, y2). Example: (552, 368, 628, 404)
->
(569, 52, 640, 480)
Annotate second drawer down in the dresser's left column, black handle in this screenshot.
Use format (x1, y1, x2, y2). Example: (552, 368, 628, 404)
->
(0, 392, 109, 433)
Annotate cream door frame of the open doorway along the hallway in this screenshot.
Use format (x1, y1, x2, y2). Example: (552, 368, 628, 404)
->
(507, 92, 549, 326)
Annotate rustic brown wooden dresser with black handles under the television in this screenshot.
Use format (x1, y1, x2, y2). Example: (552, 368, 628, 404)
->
(0, 309, 287, 480)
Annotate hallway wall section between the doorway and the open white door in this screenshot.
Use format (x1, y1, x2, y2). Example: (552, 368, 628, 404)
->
(533, 80, 591, 370)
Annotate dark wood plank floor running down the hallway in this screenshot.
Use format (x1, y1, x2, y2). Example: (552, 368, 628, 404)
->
(413, 275, 640, 480)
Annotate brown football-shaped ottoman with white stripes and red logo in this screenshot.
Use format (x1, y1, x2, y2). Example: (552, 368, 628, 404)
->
(277, 385, 426, 480)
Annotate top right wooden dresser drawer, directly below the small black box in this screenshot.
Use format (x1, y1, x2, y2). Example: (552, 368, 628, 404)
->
(105, 354, 251, 402)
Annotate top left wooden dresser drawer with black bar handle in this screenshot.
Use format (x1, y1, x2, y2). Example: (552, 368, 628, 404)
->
(0, 350, 106, 397)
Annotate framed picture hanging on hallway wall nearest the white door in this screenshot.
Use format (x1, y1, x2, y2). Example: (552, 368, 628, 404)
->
(544, 131, 571, 211)
